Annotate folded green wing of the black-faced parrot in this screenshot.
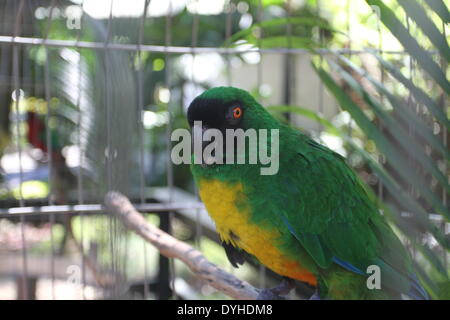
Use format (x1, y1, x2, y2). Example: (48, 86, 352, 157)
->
(280, 131, 422, 293)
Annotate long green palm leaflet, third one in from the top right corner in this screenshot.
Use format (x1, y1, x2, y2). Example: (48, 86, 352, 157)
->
(366, 0, 450, 94)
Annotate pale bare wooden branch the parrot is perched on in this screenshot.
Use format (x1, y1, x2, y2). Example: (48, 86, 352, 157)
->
(105, 192, 259, 300)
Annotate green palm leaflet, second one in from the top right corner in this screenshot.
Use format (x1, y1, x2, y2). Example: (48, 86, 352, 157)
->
(398, 0, 450, 62)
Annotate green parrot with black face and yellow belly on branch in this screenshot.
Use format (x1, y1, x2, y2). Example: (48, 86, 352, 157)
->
(187, 87, 428, 299)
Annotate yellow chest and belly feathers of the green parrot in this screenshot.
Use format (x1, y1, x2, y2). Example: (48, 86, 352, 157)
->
(199, 179, 316, 285)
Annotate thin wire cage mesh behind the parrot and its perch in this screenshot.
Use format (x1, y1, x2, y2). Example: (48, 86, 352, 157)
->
(0, 0, 449, 299)
